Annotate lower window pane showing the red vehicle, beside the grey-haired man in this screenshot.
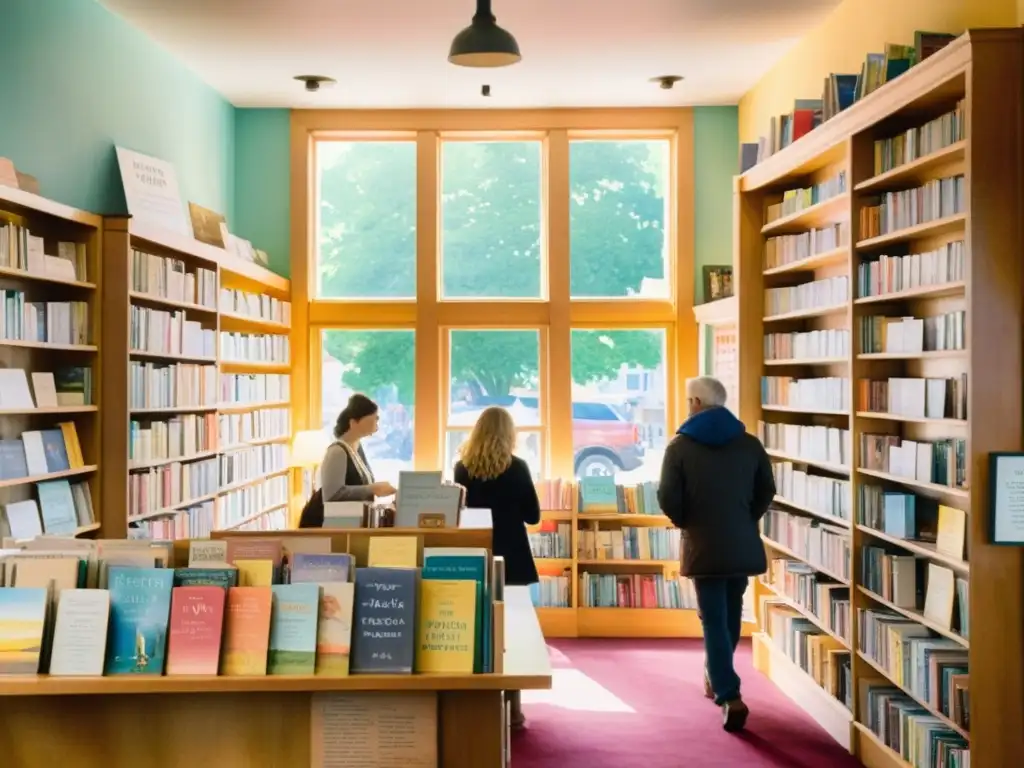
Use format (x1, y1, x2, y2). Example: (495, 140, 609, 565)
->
(572, 329, 668, 482)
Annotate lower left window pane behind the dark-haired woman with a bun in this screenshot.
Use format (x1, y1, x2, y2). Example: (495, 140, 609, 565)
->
(321, 330, 416, 485)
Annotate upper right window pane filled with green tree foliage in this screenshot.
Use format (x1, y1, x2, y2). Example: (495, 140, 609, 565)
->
(569, 140, 671, 299)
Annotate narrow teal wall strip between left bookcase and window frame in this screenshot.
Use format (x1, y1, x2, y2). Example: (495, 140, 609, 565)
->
(230, 110, 292, 275)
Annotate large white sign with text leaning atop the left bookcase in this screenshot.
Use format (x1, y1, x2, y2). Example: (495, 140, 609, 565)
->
(117, 146, 191, 237)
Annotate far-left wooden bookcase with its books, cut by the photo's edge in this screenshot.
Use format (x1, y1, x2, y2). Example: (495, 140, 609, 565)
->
(0, 186, 102, 536)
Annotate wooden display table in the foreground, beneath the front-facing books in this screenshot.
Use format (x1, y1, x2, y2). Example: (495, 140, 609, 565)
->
(0, 587, 551, 768)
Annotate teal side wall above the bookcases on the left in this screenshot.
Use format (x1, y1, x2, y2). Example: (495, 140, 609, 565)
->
(0, 0, 236, 215)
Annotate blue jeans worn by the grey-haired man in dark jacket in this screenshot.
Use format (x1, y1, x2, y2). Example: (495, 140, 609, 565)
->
(693, 577, 748, 705)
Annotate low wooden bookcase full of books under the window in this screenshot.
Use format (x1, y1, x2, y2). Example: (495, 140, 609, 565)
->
(529, 482, 754, 638)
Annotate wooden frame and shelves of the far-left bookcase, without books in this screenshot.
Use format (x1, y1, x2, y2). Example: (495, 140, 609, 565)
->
(0, 186, 103, 536)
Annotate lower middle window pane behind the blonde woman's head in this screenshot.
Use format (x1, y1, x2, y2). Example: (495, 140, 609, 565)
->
(444, 330, 543, 475)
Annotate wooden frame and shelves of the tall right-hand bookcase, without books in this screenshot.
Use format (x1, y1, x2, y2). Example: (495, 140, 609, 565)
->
(734, 29, 1024, 768)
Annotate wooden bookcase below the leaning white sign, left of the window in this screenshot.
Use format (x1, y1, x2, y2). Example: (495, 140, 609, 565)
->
(102, 218, 291, 539)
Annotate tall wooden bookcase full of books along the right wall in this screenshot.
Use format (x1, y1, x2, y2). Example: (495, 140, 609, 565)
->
(735, 29, 1024, 768)
